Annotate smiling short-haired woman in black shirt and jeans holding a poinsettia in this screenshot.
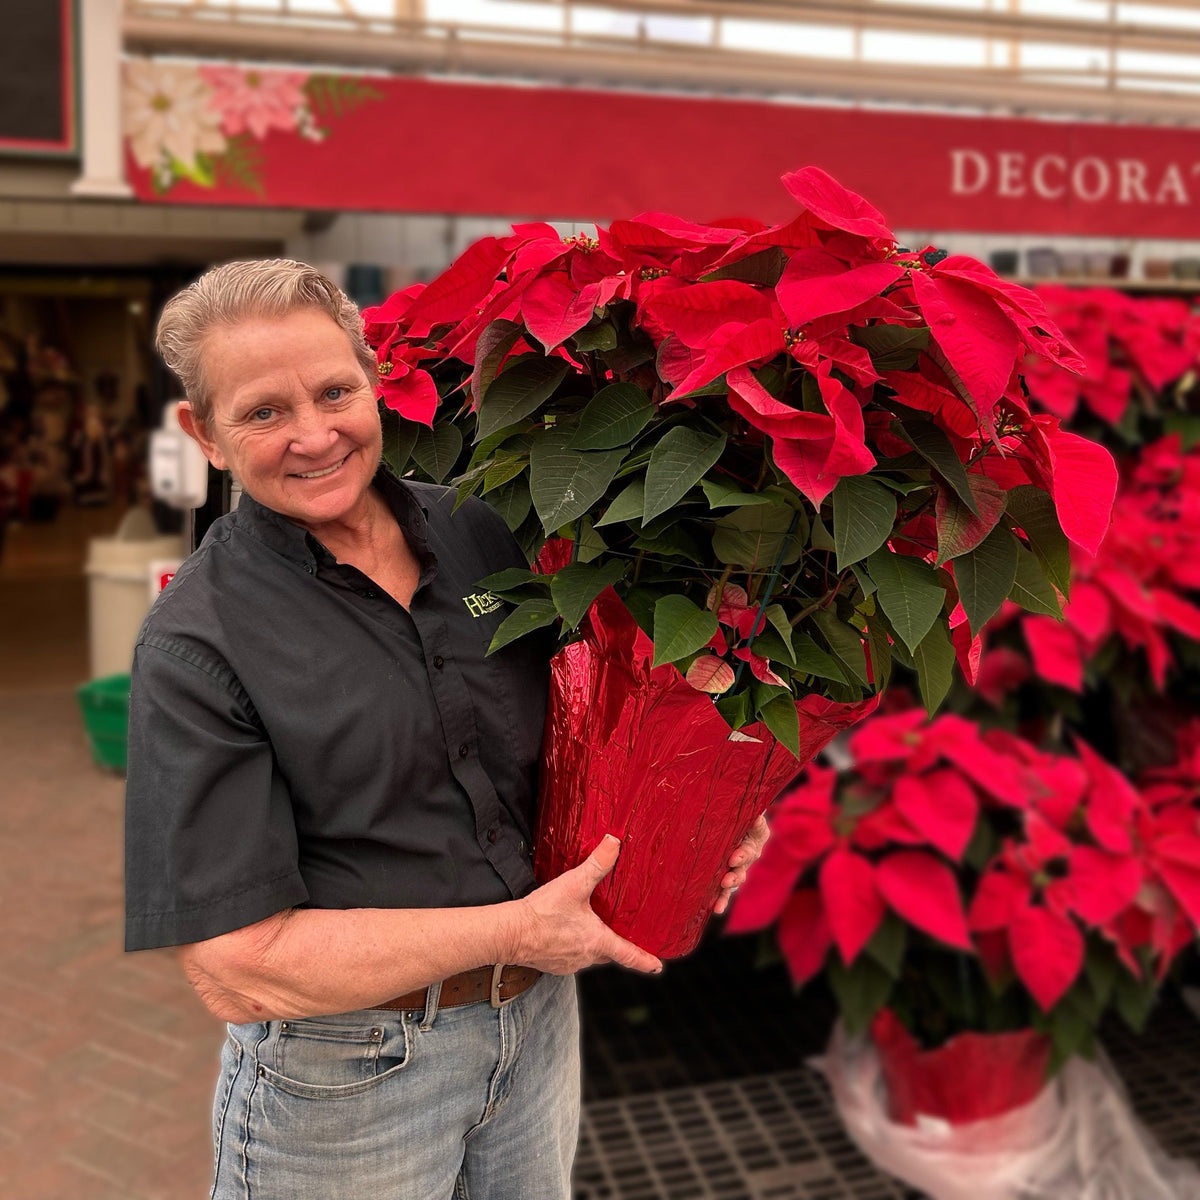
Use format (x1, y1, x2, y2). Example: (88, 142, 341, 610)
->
(126, 260, 764, 1200)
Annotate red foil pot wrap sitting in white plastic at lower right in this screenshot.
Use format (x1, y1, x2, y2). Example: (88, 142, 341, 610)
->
(871, 1008, 1050, 1126)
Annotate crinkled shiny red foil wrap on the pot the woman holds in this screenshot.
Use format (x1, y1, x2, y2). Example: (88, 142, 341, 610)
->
(534, 588, 877, 958)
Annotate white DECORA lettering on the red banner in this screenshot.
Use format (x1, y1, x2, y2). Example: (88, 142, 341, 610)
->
(950, 148, 1200, 206)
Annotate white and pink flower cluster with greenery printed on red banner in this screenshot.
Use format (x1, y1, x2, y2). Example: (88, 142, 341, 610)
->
(122, 59, 382, 197)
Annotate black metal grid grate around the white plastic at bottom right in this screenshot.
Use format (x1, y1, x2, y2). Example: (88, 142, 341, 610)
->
(575, 996, 1200, 1200)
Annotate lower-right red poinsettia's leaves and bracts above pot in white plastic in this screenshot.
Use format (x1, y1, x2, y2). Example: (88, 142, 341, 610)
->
(728, 708, 1200, 1062)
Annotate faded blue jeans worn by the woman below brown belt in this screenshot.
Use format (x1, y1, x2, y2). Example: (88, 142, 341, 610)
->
(211, 976, 580, 1200)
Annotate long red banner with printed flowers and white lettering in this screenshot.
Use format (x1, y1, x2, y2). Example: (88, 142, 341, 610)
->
(125, 60, 1200, 239)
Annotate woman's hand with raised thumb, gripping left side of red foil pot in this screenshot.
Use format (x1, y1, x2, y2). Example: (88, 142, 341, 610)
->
(508, 834, 662, 974)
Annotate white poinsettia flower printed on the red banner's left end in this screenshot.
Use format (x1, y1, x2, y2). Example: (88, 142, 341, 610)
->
(122, 59, 226, 173)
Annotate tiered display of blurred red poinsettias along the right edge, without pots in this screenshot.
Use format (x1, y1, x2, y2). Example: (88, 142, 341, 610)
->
(730, 288, 1200, 1064)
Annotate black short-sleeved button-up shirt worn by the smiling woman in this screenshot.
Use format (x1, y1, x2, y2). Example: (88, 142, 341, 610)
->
(126, 470, 550, 949)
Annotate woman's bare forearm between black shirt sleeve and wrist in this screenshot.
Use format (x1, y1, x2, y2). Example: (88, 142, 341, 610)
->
(182, 901, 517, 1024)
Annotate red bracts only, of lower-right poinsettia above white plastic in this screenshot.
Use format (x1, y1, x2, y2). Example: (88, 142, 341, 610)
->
(730, 709, 1200, 1012)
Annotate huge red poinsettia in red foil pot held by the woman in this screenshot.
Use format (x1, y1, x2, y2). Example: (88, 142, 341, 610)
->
(364, 168, 1115, 954)
